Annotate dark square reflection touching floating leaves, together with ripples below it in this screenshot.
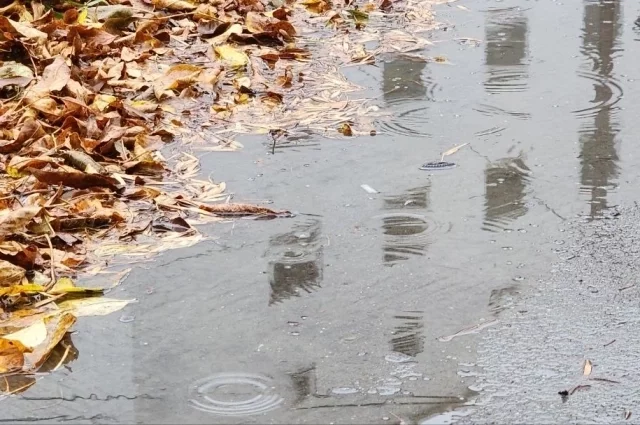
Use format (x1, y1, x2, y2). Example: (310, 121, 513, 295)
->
(380, 57, 436, 136)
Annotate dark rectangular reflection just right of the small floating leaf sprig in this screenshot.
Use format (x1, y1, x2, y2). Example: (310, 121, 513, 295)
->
(482, 158, 530, 232)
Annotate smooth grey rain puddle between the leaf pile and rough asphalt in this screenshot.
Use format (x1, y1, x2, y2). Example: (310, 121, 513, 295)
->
(7, 0, 640, 423)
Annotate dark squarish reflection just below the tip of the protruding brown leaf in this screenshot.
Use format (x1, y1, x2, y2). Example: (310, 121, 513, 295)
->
(269, 220, 324, 305)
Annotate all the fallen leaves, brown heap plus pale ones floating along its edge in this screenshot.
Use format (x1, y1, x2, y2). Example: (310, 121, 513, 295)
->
(0, 0, 442, 394)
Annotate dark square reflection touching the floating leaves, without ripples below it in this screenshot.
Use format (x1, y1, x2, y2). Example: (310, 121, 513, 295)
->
(382, 58, 429, 103)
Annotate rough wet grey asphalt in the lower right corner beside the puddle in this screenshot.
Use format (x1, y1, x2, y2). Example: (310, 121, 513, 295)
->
(460, 207, 640, 424)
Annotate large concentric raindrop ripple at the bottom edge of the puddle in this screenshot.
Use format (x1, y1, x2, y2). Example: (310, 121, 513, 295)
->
(189, 372, 284, 416)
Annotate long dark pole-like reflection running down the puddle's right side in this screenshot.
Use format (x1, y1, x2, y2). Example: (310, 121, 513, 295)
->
(577, 1, 622, 219)
